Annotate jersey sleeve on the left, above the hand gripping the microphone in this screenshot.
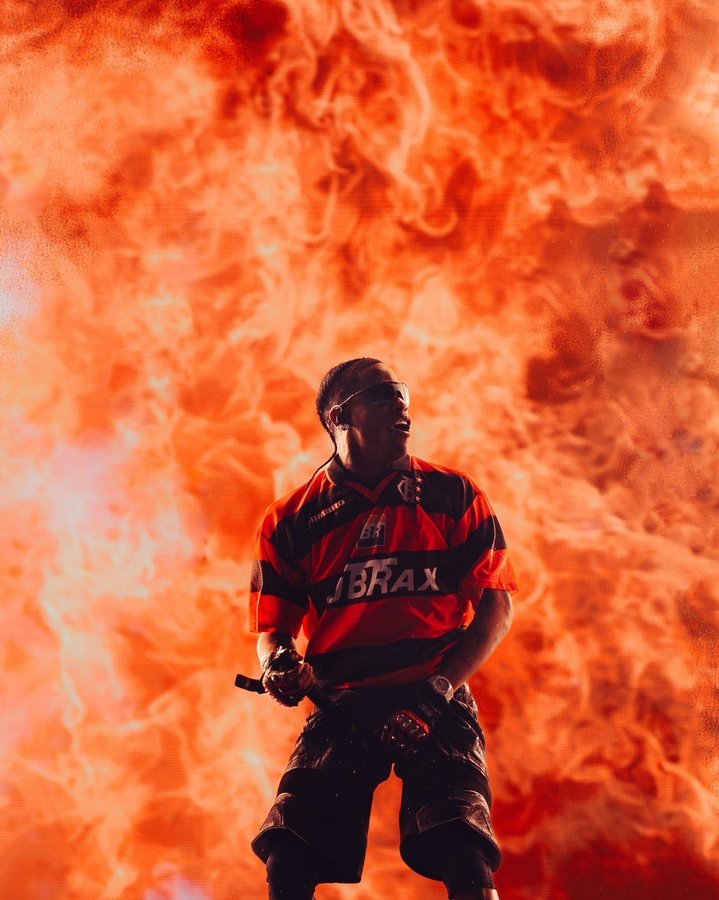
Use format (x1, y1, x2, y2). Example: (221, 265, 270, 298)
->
(250, 507, 309, 637)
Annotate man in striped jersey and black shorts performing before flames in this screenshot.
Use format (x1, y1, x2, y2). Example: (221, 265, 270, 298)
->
(251, 357, 517, 900)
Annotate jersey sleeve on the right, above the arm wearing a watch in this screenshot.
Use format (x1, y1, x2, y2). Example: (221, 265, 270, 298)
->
(449, 478, 519, 605)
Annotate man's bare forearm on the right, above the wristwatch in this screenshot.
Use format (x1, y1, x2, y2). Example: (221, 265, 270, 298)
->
(439, 588, 513, 688)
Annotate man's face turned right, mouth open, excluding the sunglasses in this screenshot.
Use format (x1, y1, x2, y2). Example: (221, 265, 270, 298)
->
(340, 363, 410, 464)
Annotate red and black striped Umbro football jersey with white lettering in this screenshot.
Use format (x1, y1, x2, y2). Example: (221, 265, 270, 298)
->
(250, 456, 517, 688)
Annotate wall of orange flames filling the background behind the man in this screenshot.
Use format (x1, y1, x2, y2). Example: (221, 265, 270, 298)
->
(0, 0, 719, 900)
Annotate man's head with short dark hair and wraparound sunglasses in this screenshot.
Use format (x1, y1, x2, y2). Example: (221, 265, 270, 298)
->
(316, 357, 410, 465)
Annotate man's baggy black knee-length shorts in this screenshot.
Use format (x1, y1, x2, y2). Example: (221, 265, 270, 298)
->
(252, 685, 502, 883)
